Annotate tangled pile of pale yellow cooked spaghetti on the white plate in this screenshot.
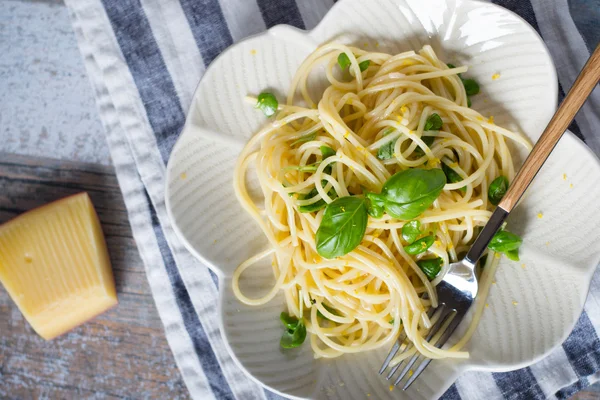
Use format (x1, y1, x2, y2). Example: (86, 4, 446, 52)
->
(233, 43, 531, 364)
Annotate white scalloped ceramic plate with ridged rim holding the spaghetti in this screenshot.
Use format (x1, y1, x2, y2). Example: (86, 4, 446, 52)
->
(166, 0, 600, 399)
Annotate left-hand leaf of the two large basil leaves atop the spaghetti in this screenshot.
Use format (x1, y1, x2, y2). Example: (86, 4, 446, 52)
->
(315, 196, 368, 259)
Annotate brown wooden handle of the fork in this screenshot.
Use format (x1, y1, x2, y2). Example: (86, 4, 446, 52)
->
(498, 45, 600, 212)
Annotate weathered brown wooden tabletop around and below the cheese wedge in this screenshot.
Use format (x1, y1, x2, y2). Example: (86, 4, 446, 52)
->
(0, 153, 189, 399)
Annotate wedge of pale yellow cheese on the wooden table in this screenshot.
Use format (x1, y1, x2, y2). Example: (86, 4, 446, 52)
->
(0, 193, 117, 340)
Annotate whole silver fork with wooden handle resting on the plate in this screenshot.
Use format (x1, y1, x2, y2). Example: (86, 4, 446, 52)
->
(379, 45, 600, 390)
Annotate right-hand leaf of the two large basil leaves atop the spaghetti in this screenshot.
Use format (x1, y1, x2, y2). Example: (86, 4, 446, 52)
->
(366, 168, 446, 220)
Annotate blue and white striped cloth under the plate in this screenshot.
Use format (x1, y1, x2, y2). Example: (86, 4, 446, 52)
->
(66, 0, 600, 400)
